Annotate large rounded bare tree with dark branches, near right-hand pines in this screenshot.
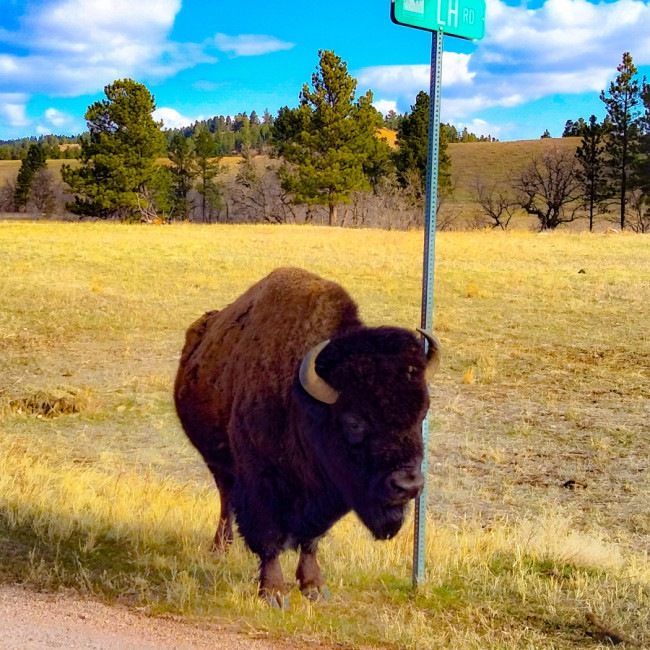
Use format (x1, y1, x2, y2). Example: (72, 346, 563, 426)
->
(515, 149, 581, 230)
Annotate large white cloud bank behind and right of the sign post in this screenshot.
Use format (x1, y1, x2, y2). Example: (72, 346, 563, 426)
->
(359, 0, 650, 128)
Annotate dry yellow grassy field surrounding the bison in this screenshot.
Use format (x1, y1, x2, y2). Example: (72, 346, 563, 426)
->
(0, 220, 650, 649)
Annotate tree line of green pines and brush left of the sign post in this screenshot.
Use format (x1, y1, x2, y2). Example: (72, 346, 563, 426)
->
(0, 50, 451, 227)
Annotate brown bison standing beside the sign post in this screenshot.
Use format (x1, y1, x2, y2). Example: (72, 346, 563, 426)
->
(174, 268, 440, 607)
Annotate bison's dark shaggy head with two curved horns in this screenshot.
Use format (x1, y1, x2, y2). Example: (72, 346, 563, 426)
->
(300, 327, 440, 539)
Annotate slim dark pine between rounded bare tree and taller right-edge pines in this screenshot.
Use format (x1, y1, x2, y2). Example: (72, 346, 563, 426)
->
(576, 115, 610, 231)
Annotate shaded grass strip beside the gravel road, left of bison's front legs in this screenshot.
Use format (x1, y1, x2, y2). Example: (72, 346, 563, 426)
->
(0, 505, 256, 615)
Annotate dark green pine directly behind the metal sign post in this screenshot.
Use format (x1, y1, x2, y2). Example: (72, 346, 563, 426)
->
(393, 91, 451, 196)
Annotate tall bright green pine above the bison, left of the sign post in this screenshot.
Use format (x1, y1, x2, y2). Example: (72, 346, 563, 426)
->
(273, 50, 388, 225)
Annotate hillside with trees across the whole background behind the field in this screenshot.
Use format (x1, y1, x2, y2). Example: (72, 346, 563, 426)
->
(0, 50, 650, 232)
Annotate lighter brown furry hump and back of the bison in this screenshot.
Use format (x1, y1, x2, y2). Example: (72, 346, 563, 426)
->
(176, 268, 361, 426)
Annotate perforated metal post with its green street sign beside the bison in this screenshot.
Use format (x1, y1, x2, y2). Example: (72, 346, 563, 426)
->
(391, 0, 485, 587)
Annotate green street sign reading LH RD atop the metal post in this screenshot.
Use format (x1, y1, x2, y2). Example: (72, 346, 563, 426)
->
(391, 0, 485, 41)
